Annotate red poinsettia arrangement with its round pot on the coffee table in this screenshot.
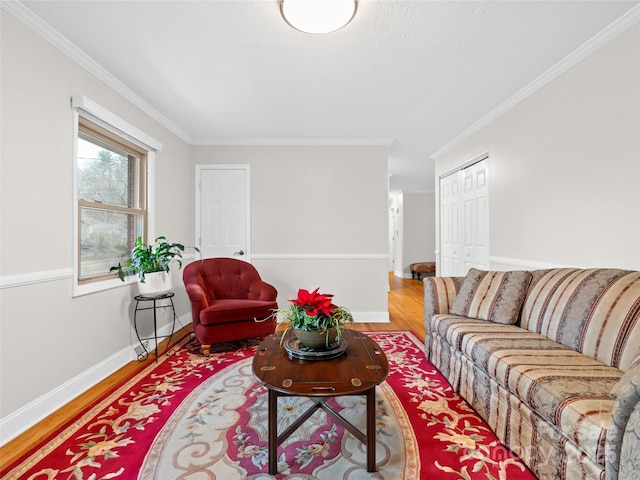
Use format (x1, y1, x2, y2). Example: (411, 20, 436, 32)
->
(276, 288, 353, 350)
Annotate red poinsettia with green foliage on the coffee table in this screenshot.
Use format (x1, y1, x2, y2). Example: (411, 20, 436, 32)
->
(276, 288, 353, 332)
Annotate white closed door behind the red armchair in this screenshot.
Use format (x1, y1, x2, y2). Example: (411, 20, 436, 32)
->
(196, 165, 250, 261)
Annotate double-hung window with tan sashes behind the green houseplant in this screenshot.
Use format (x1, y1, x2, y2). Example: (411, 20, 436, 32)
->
(76, 117, 147, 284)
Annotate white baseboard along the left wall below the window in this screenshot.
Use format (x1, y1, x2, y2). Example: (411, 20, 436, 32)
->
(0, 312, 191, 446)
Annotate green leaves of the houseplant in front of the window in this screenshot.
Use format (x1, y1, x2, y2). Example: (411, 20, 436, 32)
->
(109, 236, 185, 282)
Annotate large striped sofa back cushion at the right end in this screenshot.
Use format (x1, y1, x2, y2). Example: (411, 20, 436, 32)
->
(521, 268, 640, 371)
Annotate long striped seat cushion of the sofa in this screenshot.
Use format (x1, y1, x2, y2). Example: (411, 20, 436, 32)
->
(432, 315, 622, 465)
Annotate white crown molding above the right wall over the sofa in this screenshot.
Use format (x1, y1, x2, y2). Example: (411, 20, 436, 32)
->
(429, 5, 640, 159)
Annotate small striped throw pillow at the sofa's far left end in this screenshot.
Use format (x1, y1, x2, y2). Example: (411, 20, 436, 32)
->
(450, 268, 531, 325)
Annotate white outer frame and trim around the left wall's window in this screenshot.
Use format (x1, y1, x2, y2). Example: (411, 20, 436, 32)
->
(71, 96, 162, 297)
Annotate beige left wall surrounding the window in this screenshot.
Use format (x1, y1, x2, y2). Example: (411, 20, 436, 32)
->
(0, 12, 194, 441)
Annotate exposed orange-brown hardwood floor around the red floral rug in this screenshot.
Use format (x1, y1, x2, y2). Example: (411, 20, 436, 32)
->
(0, 274, 425, 468)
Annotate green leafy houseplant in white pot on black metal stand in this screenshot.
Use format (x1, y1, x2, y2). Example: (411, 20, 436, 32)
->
(109, 236, 188, 296)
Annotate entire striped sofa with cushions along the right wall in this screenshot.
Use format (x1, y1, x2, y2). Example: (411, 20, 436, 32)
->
(423, 268, 640, 480)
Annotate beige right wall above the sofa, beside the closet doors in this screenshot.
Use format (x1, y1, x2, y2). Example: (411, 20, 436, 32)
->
(436, 25, 640, 269)
